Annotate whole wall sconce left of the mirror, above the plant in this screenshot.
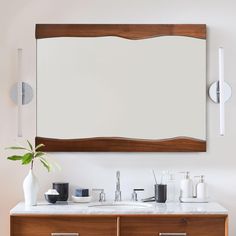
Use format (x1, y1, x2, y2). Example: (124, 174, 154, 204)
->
(10, 48, 33, 137)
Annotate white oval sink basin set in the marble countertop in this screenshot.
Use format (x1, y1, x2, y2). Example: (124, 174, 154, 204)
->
(89, 201, 152, 210)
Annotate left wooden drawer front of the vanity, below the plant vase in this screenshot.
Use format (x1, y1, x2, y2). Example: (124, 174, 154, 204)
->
(11, 216, 117, 236)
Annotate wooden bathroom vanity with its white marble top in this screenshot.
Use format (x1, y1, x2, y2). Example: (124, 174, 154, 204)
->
(10, 203, 228, 236)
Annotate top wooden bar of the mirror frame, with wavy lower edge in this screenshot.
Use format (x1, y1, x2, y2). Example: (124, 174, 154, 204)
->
(35, 24, 206, 39)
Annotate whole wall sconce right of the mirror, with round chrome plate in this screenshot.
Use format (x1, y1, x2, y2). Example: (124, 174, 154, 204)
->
(209, 47, 232, 136)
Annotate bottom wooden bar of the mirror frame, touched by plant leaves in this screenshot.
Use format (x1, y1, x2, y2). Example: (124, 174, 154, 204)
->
(35, 137, 206, 152)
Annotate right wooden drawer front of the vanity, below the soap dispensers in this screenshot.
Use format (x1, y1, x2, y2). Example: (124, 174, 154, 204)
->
(120, 217, 225, 236)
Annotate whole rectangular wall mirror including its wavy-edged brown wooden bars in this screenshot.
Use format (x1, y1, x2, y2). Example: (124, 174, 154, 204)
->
(36, 24, 206, 152)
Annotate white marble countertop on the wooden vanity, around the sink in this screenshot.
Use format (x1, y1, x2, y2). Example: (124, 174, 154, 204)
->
(10, 202, 228, 217)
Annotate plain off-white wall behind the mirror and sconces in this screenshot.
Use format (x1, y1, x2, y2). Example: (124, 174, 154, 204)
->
(0, 0, 236, 235)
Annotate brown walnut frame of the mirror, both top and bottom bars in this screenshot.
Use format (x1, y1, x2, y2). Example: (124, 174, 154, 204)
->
(35, 24, 206, 152)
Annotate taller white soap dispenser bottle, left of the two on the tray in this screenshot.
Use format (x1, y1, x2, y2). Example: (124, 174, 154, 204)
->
(180, 171, 193, 198)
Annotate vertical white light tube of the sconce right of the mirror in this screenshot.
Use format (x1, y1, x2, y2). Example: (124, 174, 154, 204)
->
(219, 47, 225, 136)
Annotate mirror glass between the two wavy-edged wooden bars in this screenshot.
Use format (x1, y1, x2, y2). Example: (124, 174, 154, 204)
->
(37, 36, 206, 140)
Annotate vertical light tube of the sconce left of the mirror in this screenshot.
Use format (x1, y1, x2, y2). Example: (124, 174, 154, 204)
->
(17, 48, 23, 137)
